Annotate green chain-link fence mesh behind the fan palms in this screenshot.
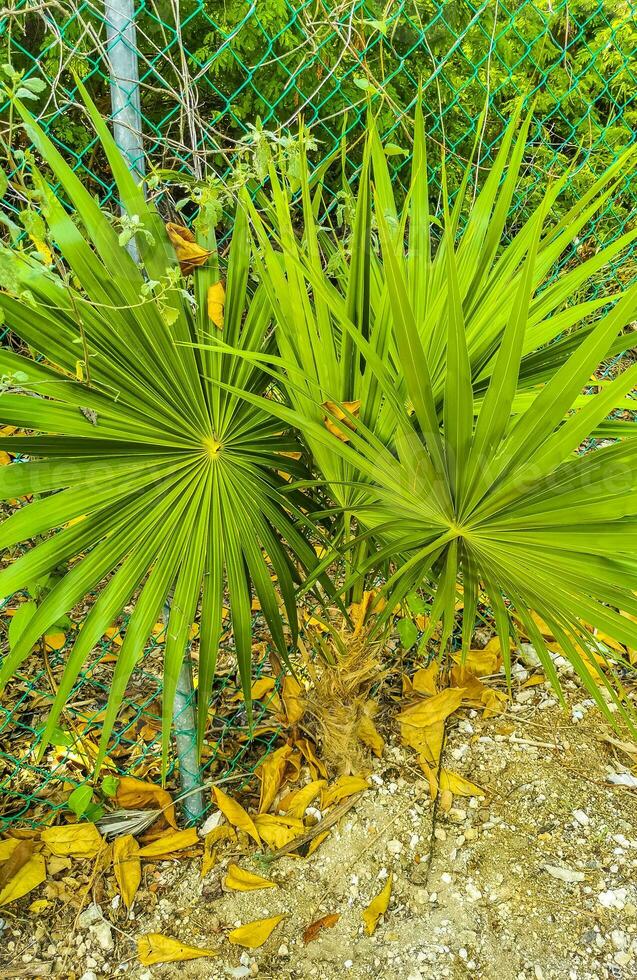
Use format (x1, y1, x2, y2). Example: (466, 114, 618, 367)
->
(0, 0, 637, 830)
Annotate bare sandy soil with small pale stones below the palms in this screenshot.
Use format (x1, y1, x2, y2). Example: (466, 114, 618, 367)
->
(0, 682, 637, 980)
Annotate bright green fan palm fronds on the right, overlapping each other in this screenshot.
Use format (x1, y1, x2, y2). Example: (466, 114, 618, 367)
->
(210, 105, 637, 710)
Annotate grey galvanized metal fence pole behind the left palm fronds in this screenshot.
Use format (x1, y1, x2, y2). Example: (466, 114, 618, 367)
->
(104, 0, 204, 823)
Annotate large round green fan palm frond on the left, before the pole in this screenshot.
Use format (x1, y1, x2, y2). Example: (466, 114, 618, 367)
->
(0, 86, 316, 761)
